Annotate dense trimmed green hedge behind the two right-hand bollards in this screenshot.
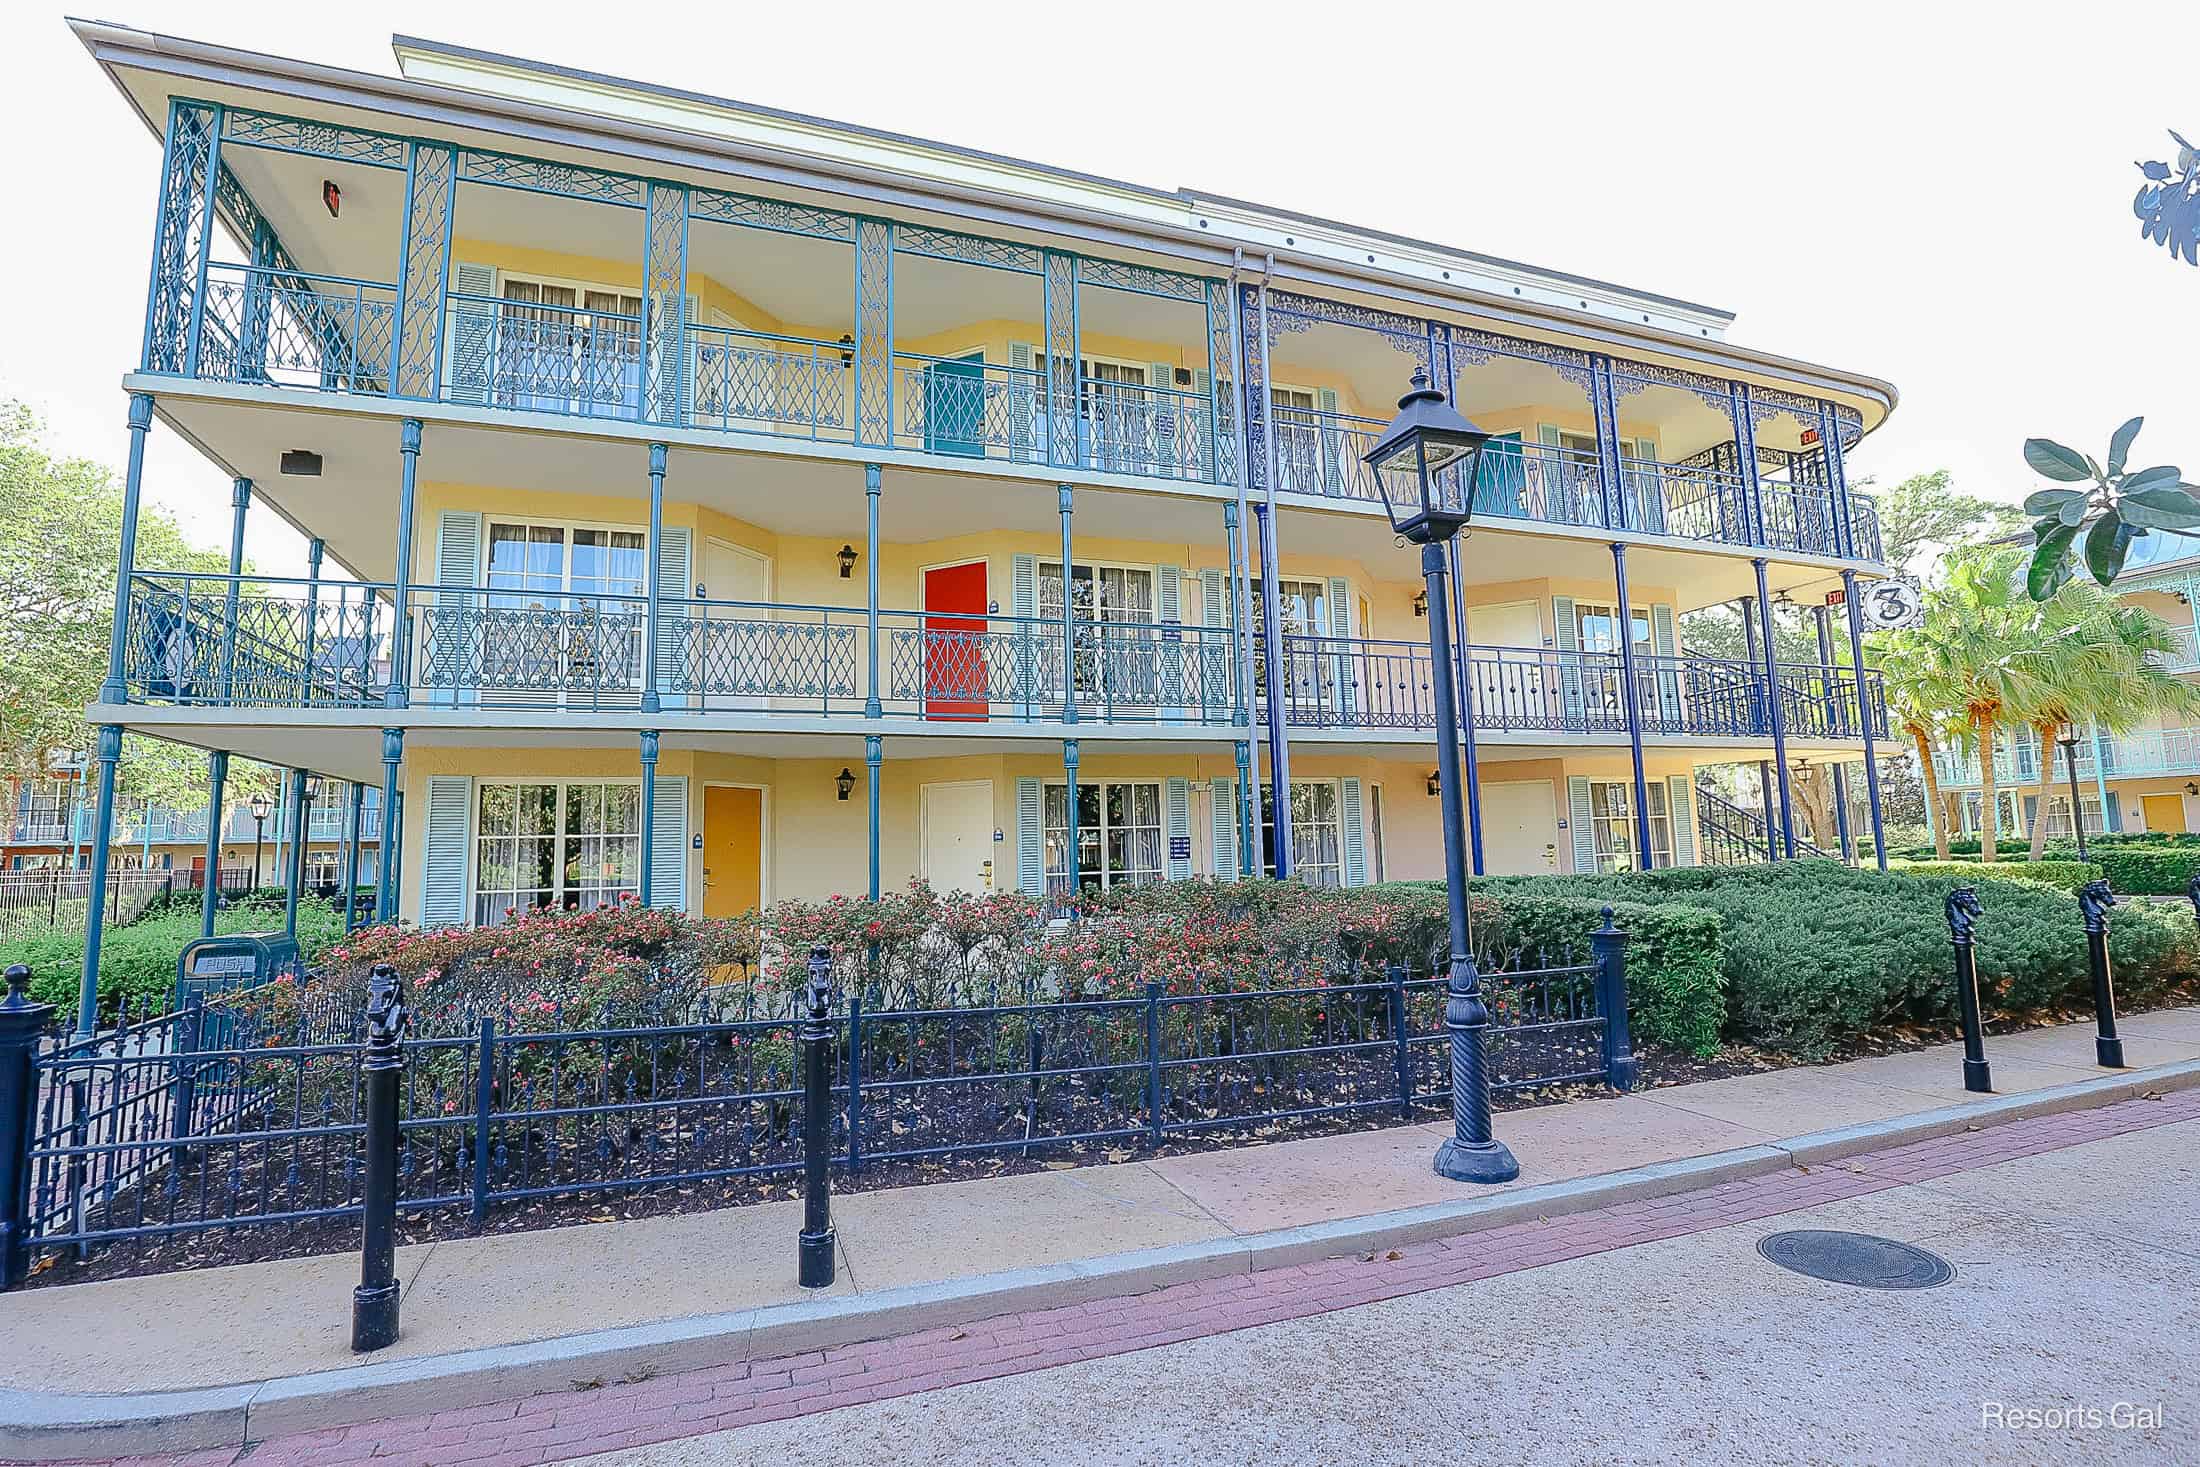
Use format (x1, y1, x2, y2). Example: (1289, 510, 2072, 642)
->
(1478, 860, 2196, 1058)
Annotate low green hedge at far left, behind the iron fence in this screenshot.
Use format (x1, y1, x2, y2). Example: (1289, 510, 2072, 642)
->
(0, 893, 343, 1018)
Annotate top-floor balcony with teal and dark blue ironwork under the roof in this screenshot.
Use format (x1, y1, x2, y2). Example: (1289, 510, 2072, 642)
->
(143, 101, 1881, 561)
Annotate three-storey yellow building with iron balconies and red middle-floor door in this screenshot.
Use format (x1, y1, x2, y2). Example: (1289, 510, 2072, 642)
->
(75, 22, 1894, 924)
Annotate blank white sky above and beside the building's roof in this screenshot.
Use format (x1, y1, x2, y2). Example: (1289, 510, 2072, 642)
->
(0, 0, 2200, 574)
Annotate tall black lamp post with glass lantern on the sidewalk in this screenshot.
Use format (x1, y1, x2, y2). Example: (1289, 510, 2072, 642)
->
(1366, 372, 1520, 1181)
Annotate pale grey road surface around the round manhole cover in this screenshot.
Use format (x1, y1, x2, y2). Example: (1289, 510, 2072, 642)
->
(590, 1122, 2200, 1467)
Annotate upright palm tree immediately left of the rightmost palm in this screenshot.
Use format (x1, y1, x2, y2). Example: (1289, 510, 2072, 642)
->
(1910, 550, 2046, 862)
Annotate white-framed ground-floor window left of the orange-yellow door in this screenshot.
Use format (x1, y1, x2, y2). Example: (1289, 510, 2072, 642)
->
(473, 783, 642, 924)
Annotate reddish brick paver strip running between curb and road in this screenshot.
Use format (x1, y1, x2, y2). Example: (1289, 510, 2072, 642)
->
(34, 1089, 2200, 1467)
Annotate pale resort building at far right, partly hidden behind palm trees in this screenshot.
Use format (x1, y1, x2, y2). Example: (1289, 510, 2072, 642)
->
(1934, 530, 2200, 840)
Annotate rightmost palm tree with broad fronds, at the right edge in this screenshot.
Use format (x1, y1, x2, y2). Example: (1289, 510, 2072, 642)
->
(2011, 578, 2200, 860)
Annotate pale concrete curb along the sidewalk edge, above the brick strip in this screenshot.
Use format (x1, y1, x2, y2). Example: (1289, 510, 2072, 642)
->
(0, 1060, 2200, 1460)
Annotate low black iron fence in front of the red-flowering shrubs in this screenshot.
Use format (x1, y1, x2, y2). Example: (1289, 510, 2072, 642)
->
(0, 936, 1624, 1282)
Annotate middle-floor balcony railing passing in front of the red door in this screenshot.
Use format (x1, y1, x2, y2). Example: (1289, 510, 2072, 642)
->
(125, 572, 1885, 747)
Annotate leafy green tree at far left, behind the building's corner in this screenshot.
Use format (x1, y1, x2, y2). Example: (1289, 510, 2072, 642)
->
(0, 402, 229, 805)
